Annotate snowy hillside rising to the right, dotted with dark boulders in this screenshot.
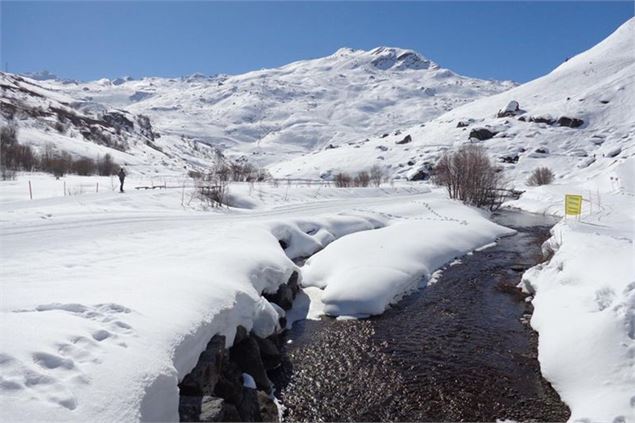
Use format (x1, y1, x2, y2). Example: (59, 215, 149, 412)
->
(270, 19, 635, 187)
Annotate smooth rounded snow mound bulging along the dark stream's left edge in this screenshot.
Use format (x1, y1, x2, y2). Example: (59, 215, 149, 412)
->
(302, 200, 513, 316)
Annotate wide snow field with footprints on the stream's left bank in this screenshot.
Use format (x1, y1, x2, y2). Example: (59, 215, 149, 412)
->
(0, 180, 438, 422)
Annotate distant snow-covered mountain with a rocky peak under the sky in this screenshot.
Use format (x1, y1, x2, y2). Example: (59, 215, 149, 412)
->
(3, 47, 514, 176)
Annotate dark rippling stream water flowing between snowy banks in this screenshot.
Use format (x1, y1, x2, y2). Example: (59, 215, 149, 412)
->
(271, 212, 569, 421)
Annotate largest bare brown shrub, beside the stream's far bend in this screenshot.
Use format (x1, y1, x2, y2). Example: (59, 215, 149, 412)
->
(434, 145, 505, 210)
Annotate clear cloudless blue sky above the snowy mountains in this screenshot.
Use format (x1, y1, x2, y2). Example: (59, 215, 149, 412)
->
(0, 0, 633, 82)
